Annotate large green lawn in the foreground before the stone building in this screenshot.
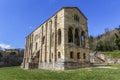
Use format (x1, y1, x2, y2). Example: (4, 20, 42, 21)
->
(0, 65, 120, 80)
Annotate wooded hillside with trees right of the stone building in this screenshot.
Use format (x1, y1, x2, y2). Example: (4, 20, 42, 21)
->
(89, 27, 120, 51)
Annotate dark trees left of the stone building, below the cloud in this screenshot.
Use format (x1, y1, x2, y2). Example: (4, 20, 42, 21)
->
(0, 49, 24, 67)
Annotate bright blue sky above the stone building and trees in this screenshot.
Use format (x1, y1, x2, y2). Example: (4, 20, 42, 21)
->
(0, 0, 120, 48)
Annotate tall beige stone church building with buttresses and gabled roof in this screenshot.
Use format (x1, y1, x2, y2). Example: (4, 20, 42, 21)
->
(21, 7, 90, 70)
